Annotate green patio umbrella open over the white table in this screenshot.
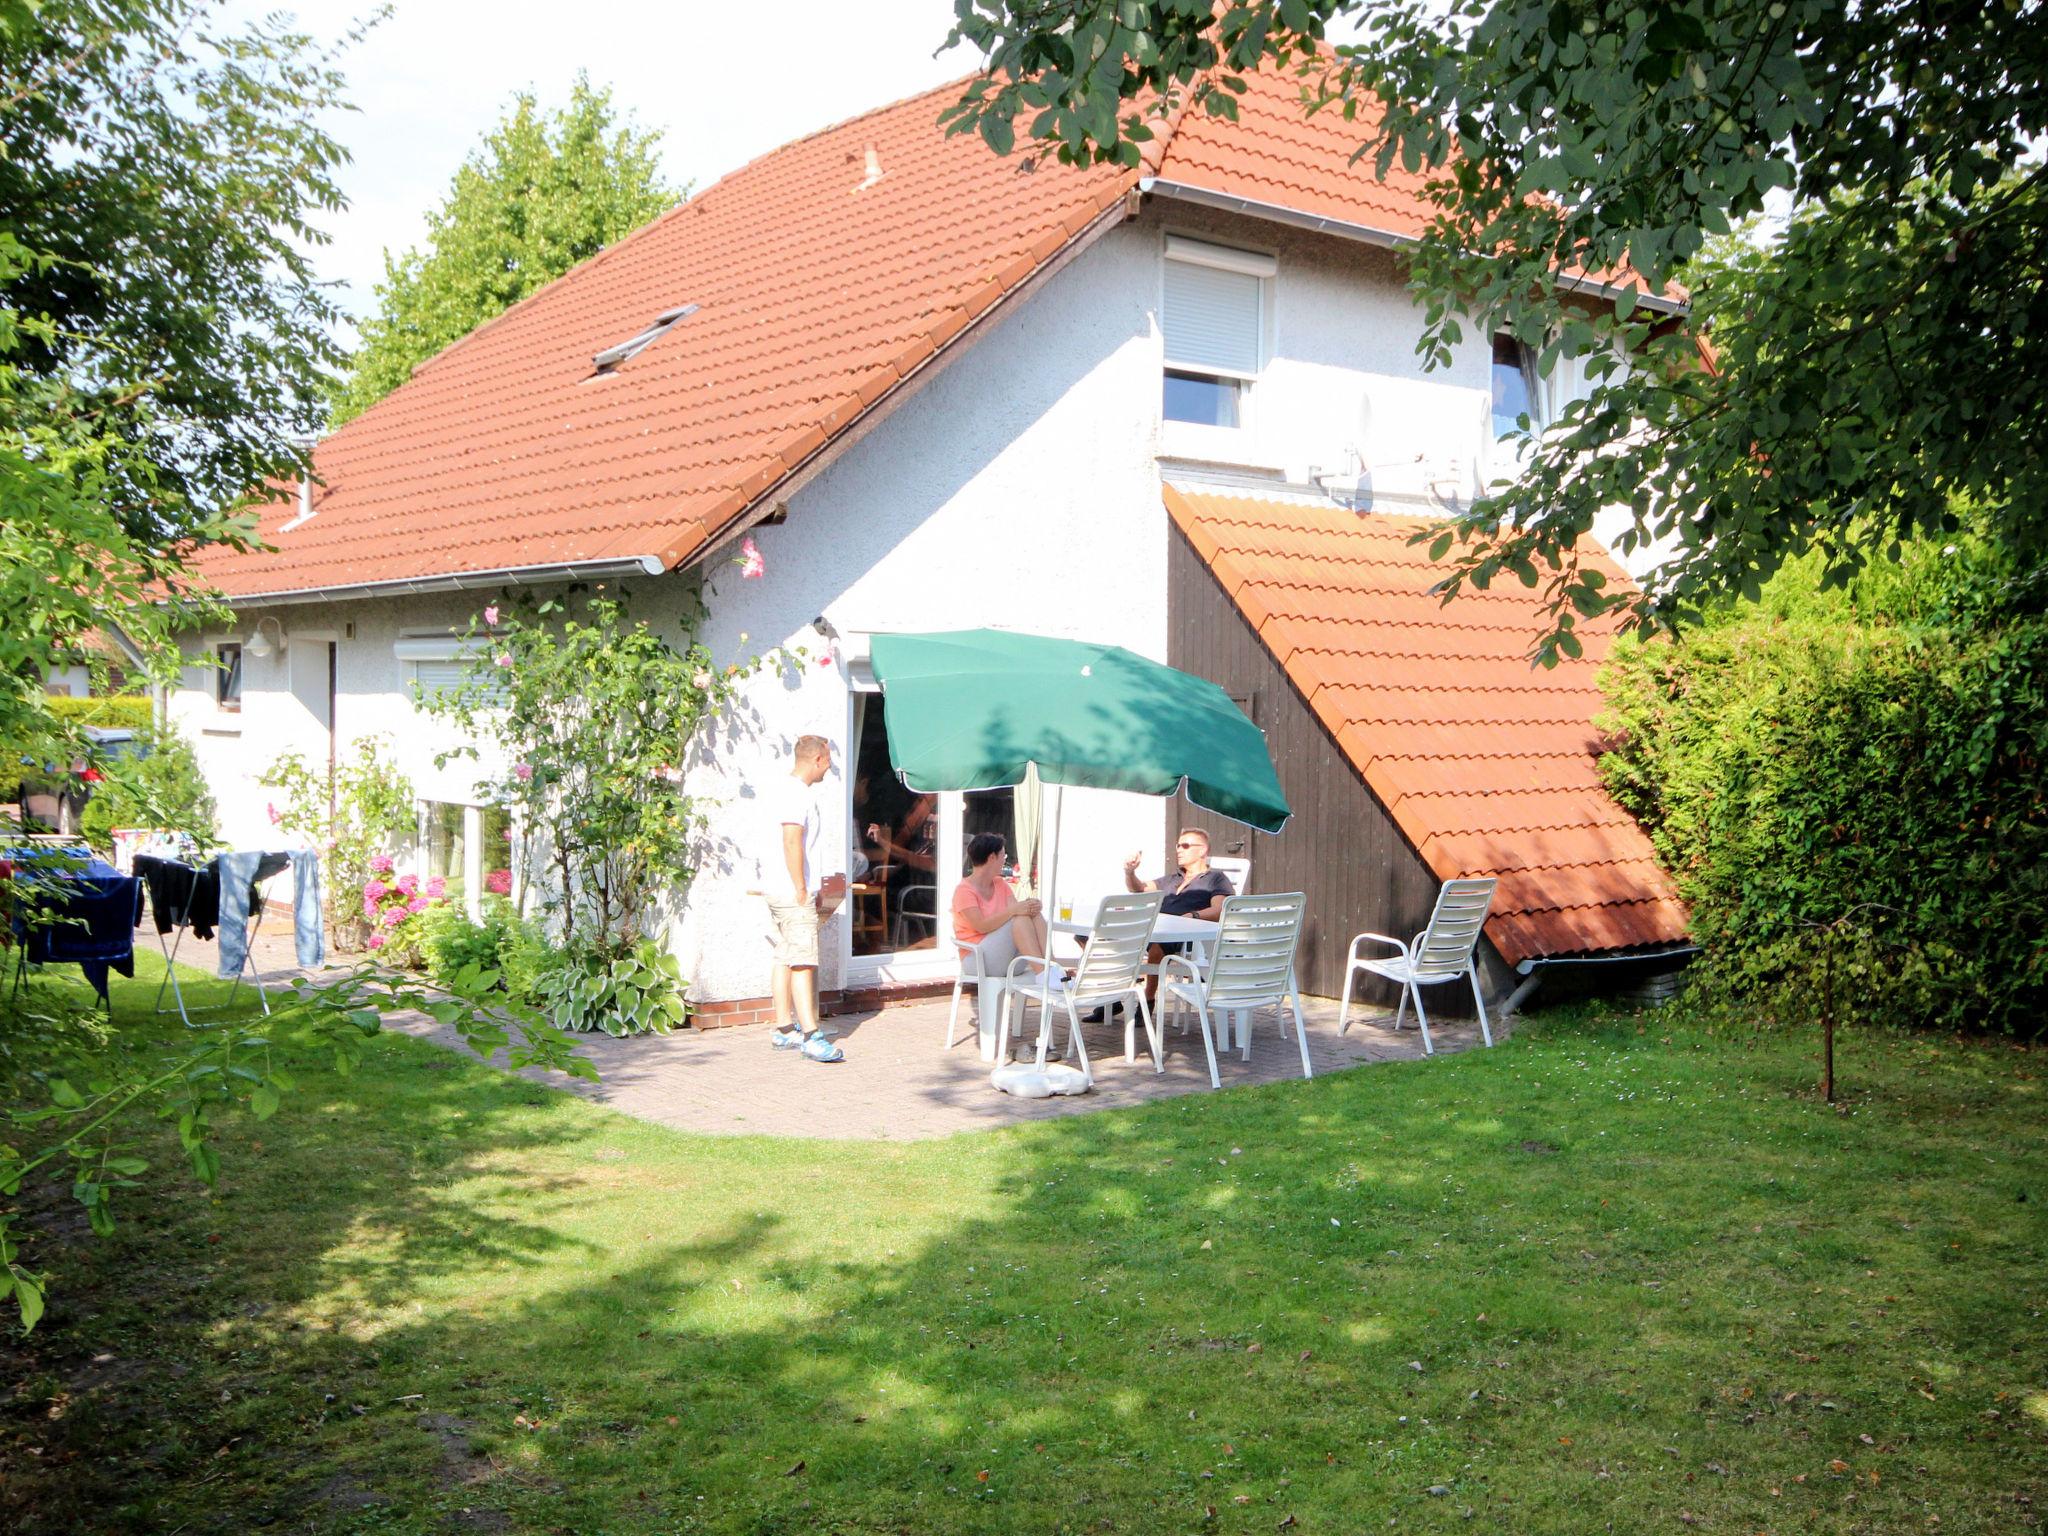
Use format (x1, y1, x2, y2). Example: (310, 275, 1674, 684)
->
(870, 629, 1288, 909)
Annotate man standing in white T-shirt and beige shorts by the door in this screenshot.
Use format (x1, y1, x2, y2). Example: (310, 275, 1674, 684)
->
(760, 735, 846, 1061)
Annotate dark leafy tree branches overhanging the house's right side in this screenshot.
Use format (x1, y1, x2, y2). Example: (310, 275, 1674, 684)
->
(948, 0, 2048, 662)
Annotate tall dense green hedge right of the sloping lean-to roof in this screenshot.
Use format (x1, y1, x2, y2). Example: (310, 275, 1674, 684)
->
(1602, 573, 2048, 1034)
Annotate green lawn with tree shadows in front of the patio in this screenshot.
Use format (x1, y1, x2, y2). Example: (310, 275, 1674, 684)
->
(0, 971, 2048, 1536)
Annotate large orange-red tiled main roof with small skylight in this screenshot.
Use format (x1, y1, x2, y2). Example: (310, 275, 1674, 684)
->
(197, 61, 1572, 612)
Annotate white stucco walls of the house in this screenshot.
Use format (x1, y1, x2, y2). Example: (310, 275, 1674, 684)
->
(172, 195, 1613, 999)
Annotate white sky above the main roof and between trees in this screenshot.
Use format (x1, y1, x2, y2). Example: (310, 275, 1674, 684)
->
(225, 0, 977, 339)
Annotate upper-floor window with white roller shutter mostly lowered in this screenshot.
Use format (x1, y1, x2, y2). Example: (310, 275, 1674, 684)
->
(1159, 236, 1276, 428)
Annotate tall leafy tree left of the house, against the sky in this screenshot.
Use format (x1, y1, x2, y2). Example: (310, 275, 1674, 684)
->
(0, 0, 346, 786)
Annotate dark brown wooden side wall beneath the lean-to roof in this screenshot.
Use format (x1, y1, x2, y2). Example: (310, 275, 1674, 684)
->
(1167, 528, 1513, 1018)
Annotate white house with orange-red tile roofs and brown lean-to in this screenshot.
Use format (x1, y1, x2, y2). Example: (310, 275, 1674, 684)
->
(170, 66, 1683, 1018)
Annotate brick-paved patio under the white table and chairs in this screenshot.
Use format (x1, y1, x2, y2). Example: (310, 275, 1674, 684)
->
(184, 932, 1503, 1141)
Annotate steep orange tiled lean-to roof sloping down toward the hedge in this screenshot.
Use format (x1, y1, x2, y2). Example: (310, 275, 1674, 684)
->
(1165, 487, 1686, 961)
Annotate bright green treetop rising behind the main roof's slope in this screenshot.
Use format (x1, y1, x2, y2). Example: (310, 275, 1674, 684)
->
(334, 76, 682, 424)
